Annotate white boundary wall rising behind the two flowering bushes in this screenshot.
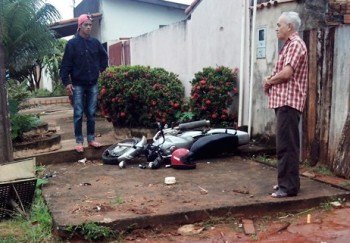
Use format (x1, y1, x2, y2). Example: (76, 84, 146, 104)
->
(131, 0, 249, 123)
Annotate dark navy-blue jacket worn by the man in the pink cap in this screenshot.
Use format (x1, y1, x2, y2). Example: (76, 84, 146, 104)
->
(60, 35, 108, 86)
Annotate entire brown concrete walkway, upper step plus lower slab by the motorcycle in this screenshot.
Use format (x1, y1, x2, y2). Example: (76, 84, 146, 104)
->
(17, 99, 350, 236)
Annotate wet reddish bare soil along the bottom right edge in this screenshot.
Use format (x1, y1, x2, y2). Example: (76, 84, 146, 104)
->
(122, 206, 350, 243)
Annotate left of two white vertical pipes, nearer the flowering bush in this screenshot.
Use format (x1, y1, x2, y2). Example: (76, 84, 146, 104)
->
(238, 0, 247, 127)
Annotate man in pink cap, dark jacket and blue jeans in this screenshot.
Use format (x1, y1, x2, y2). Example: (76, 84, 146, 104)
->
(60, 14, 108, 153)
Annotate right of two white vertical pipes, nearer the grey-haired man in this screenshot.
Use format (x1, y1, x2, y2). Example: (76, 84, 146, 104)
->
(248, 0, 257, 137)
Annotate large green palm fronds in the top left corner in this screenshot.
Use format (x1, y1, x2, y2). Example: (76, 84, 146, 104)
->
(0, 0, 60, 90)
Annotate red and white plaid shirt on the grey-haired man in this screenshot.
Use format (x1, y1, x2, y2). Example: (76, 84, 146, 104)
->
(269, 33, 308, 112)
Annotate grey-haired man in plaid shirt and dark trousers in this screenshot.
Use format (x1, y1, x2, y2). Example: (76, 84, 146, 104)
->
(264, 12, 308, 198)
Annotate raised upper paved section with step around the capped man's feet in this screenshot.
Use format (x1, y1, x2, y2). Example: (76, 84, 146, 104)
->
(15, 99, 117, 165)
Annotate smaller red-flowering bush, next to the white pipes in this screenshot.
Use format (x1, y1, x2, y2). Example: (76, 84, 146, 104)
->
(190, 67, 238, 126)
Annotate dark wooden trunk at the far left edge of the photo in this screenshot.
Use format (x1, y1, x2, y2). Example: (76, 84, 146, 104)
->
(0, 30, 13, 164)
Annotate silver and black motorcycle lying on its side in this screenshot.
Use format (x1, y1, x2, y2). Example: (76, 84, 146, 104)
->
(102, 120, 249, 169)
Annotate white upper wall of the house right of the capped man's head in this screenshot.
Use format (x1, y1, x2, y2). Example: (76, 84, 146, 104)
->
(100, 0, 186, 43)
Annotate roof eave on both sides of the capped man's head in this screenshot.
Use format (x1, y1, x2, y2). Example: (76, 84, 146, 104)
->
(50, 13, 102, 38)
